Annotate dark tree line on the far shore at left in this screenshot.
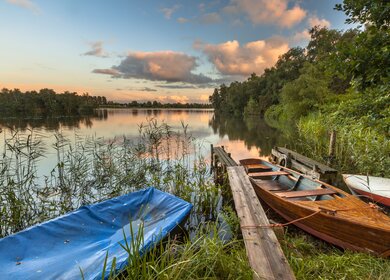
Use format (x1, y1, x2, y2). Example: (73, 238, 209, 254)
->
(0, 88, 107, 116)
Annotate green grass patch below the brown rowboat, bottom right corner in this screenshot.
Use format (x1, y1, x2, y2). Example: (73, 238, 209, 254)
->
(281, 232, 390, 280)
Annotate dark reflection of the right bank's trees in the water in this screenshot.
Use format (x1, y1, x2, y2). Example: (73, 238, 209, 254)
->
(209, 114, 294, 156)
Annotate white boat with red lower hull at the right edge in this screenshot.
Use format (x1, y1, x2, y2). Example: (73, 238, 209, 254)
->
(343, 174, 390, 207)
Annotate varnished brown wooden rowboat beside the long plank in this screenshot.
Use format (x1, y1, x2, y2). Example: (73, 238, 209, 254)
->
(240, 159, 390, 257)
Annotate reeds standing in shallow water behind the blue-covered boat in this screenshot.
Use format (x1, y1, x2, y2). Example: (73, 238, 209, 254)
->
(0, 120, 222, 236)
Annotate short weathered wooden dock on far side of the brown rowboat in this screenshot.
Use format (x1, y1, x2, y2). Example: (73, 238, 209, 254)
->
(271, 147, 337, 184)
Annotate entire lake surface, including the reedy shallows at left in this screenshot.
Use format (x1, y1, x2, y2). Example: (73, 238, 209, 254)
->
(0, 109, 294, 237)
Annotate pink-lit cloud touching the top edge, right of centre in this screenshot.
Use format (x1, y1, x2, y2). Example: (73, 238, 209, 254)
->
(223, 0, 307, 28)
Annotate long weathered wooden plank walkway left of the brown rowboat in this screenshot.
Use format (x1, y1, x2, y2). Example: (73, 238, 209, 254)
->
(227, 166, 295, 280)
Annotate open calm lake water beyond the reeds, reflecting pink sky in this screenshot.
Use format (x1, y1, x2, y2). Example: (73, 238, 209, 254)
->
(0, 109, 288, 175)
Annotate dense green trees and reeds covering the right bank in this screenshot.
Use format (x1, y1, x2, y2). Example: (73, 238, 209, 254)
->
(210, 0, 390, 177)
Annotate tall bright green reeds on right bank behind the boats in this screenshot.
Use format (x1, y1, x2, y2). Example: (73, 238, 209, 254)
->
(298, 114, 390, 177)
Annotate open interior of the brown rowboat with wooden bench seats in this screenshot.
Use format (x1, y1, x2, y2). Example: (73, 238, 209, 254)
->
(240, 159, 345, 201)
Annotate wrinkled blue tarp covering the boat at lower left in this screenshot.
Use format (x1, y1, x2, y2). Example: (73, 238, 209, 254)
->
(0, 188, 192, 280)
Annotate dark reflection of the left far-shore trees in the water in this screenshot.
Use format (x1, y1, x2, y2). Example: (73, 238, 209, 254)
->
(0, 110, 108, 131)
